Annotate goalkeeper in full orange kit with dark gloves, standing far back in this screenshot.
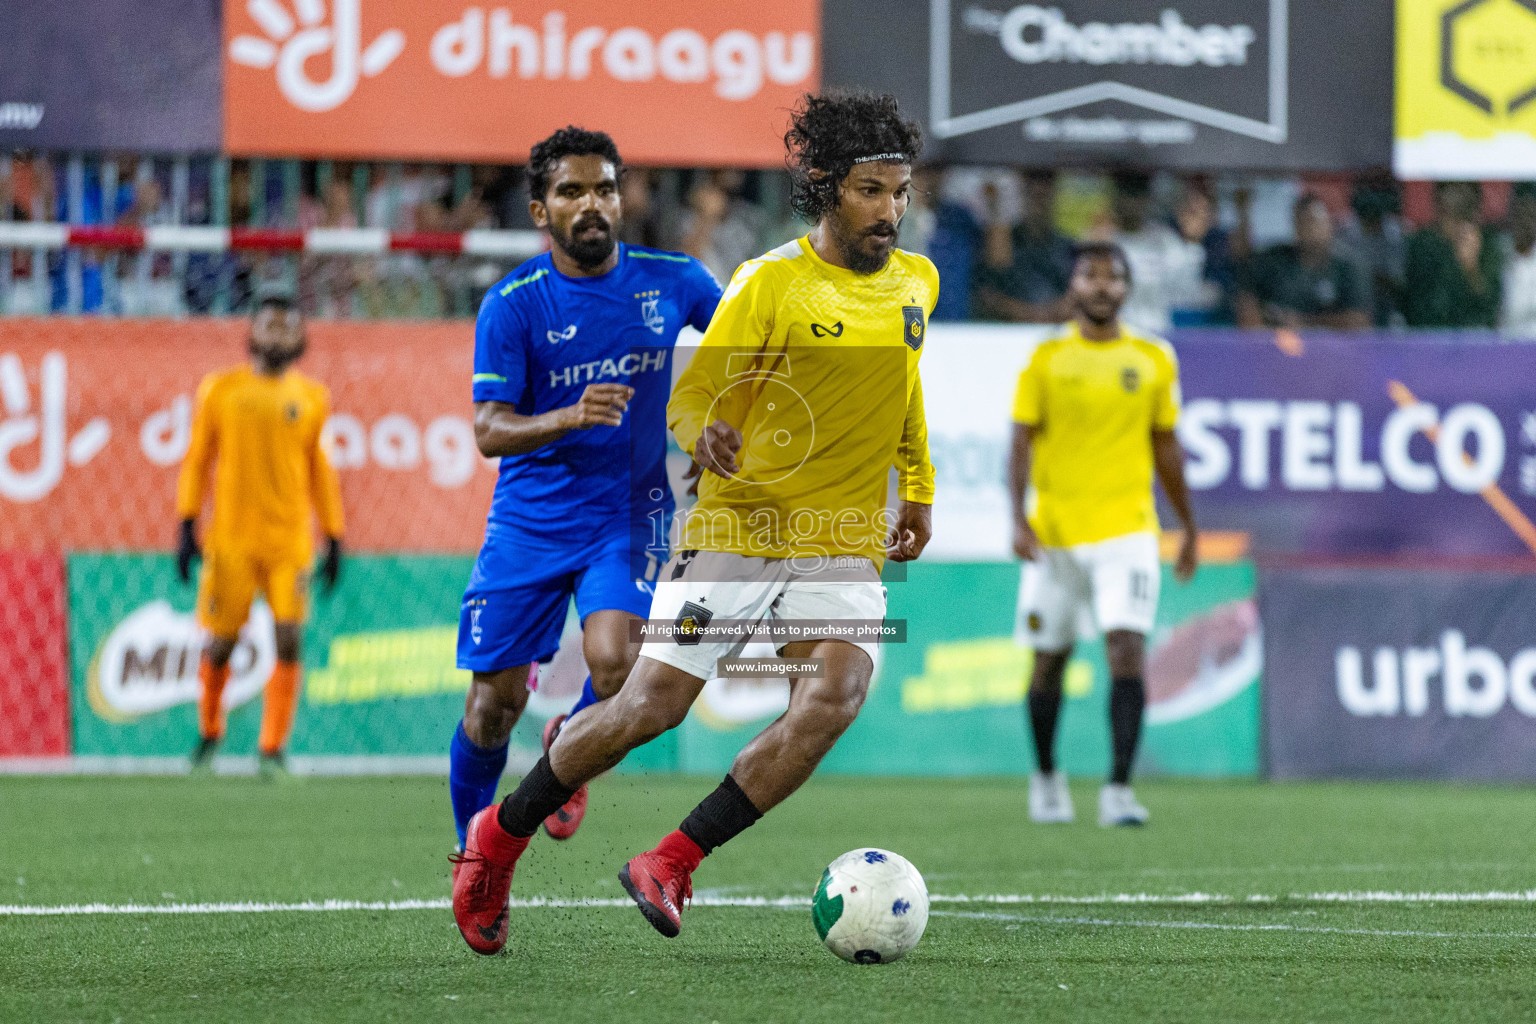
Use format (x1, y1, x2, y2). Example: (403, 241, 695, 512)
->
(177, 298, 343, 774)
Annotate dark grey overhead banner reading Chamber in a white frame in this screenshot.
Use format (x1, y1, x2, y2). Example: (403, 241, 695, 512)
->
(825, 0, 1393, 170)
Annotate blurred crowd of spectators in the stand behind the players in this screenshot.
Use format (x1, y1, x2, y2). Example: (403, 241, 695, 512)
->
(0, 154, 1536, 339)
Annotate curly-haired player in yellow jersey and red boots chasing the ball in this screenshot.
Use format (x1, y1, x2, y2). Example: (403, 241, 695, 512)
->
(453, 94, 938, 953)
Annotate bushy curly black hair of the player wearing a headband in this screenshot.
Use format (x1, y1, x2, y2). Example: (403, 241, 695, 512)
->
(783, 91, 923, 221)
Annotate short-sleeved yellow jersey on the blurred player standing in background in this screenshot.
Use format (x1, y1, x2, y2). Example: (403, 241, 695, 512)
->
(1014, 322, 1180, 548)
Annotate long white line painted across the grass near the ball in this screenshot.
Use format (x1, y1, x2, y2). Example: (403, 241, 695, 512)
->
(9, 889, 1536, 935)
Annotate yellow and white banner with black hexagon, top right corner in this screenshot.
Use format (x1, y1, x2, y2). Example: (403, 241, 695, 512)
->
(1395, 0, 1536, 180)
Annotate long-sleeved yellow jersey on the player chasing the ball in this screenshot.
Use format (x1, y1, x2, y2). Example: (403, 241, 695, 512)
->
(667, 236, 938, 565)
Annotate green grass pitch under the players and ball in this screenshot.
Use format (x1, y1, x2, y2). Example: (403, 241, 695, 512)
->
(0, 775, 1536, 1024)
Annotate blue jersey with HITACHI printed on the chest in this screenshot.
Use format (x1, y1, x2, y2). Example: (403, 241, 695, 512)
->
(473, 244, 720, 555)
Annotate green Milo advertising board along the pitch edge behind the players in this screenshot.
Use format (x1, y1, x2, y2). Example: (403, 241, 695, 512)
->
(69, 554, 1260, 775)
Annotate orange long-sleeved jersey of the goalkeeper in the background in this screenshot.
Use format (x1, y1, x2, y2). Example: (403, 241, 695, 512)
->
(177, 367, 343, 563)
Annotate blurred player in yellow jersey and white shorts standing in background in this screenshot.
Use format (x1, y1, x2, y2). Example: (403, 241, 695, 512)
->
(1008, 243, 1197, 826)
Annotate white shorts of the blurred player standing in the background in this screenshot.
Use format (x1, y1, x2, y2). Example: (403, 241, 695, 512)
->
(1014, 533, 1163, 651)
